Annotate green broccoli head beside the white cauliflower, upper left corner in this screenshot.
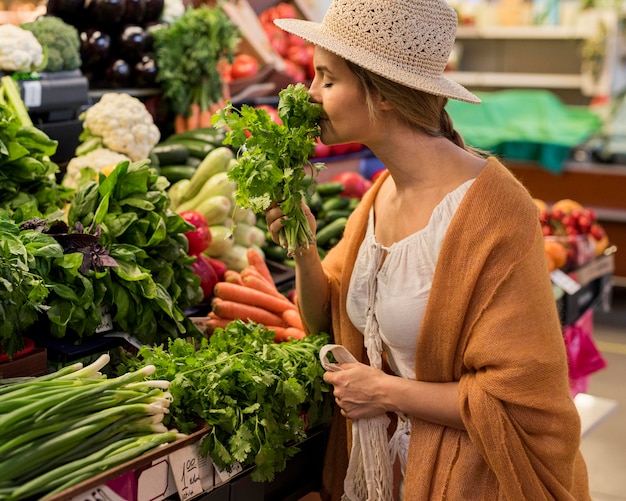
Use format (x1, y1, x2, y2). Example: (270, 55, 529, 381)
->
(21, 16, 82, 72)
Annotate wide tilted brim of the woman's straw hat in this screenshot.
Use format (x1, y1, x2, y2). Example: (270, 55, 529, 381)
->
(274, 19, 481, 104)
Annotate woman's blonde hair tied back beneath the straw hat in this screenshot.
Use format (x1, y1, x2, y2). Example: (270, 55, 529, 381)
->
(346, 60, 486, 156)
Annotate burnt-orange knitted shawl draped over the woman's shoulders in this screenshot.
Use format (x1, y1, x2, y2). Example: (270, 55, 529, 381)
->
(322, 158, 590, 501)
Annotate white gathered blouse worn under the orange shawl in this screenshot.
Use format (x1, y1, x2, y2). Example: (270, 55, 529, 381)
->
(346, 179, 474, 379)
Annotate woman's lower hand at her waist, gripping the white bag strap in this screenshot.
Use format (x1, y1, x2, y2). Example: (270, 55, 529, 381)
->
(324, 363, 394, 419)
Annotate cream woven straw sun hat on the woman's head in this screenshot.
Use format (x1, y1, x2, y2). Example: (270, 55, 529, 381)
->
(274, 0, 480, 103)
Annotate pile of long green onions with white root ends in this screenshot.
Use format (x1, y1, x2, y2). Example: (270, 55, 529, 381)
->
(0, 355, 181, 501)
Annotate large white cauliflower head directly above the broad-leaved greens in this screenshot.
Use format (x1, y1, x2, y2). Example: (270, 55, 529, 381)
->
(81, 92, 161, 161)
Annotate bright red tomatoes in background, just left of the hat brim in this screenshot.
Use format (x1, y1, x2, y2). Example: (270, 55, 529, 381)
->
(259, 2, 315, 83)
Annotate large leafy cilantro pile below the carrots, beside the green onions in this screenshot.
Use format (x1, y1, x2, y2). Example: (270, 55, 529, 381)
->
(117, 320, 332, 481)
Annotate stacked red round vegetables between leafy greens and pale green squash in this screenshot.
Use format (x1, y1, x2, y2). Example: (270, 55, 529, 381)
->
(180, 210, 226, 300)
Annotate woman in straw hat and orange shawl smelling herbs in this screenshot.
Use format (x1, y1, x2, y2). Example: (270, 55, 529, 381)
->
(266, 0, 589, 501)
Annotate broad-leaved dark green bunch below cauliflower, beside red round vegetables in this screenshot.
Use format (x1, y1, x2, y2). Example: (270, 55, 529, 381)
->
(68, 160, 203, 344)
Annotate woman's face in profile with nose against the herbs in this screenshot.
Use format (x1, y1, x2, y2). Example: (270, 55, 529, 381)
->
(310, 47, 375, 145)
